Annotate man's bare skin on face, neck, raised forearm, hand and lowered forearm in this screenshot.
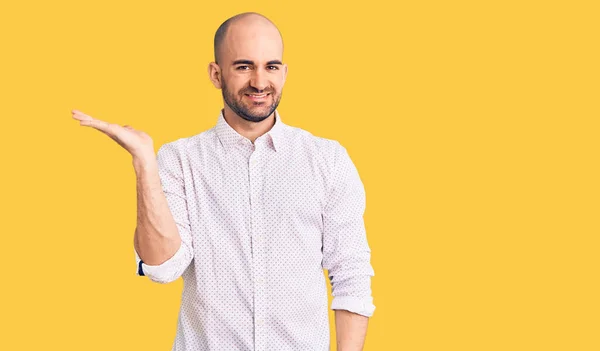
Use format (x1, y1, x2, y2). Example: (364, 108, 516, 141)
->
(72, 14, 369, 351)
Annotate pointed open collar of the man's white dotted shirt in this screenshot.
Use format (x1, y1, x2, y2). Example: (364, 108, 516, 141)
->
(215, 109, 285, 151)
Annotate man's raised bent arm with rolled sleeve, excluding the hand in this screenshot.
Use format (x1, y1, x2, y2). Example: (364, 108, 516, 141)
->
(133, 143, 193, 283)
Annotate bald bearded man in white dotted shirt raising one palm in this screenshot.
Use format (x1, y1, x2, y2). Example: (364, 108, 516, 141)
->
(73, 13, 375, 351)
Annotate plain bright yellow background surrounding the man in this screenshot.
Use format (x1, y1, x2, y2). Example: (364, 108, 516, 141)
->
(0, 1, 600, 351)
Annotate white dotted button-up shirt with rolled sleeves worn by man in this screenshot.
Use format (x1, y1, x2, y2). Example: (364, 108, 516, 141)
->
(134, 110, 375, 351)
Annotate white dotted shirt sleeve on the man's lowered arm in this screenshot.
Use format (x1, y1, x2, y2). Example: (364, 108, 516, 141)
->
(323, 141, 375, 317)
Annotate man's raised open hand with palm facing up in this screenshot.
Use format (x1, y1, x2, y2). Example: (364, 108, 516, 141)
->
(71, 110, 155, 160)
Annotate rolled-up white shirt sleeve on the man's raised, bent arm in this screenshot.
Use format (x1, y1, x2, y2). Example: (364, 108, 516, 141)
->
(133, 142, 194, 284)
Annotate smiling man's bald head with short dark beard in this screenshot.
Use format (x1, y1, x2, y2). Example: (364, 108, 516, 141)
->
(208, 12, 287, 122)
